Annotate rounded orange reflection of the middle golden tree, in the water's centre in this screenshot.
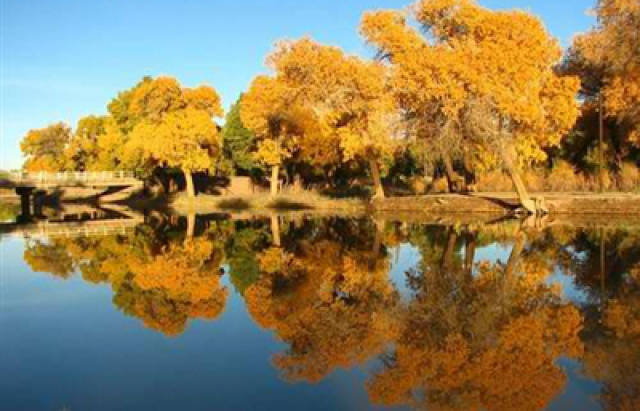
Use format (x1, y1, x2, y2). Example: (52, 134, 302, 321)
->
(245, 220, 397, 382)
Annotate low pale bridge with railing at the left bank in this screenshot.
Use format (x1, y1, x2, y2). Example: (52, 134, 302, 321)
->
(0, 171, 144, 217)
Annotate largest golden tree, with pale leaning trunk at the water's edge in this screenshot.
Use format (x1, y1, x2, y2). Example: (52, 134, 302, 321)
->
(361, 0, 579, 212)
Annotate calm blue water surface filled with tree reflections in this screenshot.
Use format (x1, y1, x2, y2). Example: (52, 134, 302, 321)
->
(0, 214, 640, 410)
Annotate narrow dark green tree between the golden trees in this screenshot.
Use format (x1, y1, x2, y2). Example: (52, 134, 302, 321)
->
(222, 95, 259, 174)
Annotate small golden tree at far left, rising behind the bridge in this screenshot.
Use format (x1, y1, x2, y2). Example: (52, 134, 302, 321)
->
(20, 123, 71, 171)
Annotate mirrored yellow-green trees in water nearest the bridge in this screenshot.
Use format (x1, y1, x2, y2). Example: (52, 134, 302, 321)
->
(24, 217, 228, 336)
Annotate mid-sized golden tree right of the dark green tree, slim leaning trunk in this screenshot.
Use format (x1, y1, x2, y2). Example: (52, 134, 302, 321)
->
(243, 38, 395, 197)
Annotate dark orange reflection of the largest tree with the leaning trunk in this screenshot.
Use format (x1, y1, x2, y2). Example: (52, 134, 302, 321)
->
(367, 228, 582, 409)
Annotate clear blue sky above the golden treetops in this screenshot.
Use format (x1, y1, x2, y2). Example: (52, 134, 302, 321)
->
(0, 0, 595, 169)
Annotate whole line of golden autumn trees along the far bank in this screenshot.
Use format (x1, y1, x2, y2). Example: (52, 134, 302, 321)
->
(21, 0, 640, 213)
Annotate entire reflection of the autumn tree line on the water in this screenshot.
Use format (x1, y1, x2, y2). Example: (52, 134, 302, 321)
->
(5, 214, 640, 410)
